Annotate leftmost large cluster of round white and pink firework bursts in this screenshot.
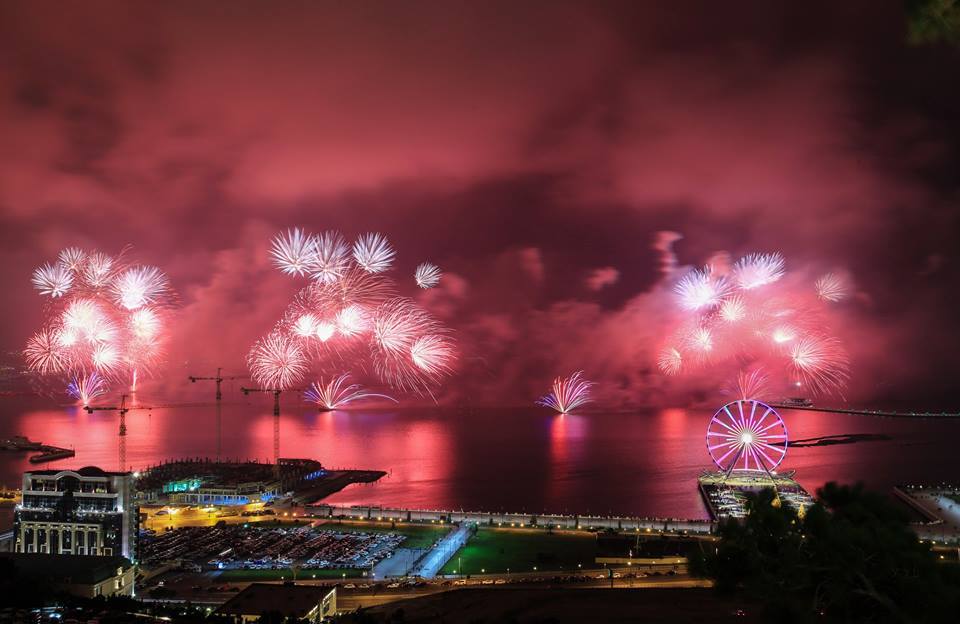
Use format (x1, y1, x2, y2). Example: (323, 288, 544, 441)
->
(23, 247, 175, 397)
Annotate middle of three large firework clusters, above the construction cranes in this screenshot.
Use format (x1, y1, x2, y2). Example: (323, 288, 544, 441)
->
(248, 229, 456, 395)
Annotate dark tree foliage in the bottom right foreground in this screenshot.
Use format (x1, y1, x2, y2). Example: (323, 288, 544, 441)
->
(693, 483, 960, 623)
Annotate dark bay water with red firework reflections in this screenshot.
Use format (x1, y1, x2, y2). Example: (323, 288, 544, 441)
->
(0, 397, 960, 518)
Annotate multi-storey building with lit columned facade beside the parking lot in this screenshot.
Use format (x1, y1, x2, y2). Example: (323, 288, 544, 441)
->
(14, 466, 139, 561)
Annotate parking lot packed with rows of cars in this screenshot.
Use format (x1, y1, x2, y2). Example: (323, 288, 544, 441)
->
(141, 524, 405, 571)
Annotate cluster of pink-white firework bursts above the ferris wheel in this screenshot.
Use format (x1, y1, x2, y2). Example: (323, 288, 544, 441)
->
(657, 253, 850, 398)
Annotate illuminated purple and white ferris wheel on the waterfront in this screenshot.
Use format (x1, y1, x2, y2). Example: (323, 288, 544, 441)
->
(707, 399, 787, 473)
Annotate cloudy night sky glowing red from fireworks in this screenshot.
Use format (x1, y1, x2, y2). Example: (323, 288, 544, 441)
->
(0, 0, 960, 407)
